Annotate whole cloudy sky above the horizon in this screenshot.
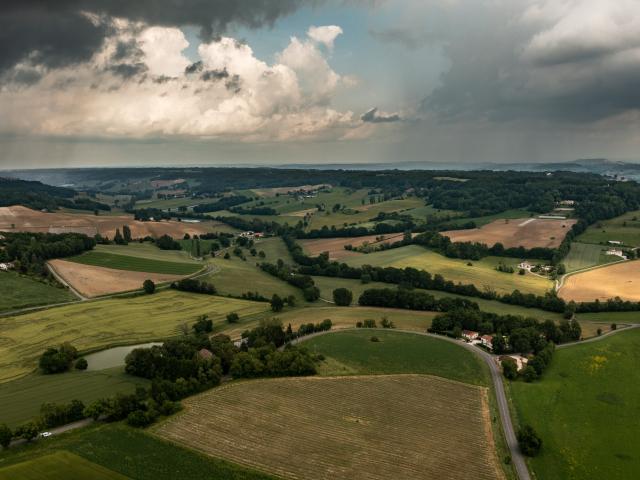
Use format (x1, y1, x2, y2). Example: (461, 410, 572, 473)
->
(0, 0, 640, 168)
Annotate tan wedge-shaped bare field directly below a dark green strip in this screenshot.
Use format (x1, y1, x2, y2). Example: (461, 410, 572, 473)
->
(49, 259, 182, 298)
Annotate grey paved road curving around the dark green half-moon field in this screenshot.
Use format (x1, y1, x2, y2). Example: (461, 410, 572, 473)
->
(291, 329, 531, 480)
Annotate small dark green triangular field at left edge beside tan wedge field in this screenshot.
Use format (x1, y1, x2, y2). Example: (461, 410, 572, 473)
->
(0, 272, 76, 312)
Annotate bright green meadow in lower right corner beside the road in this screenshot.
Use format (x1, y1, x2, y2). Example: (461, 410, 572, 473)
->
(511, 330, 640, 480)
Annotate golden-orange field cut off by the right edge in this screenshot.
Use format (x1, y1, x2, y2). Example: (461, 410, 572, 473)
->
(559, 260, 640, 302)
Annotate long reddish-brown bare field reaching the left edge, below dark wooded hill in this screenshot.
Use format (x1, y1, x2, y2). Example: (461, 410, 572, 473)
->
(0, 205, 225, 238)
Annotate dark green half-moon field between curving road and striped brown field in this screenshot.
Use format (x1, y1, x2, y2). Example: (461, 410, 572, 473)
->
(302, 328, 489, 386)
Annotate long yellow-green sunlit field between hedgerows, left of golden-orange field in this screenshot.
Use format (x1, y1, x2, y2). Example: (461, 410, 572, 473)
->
(344, 245, 553, 295)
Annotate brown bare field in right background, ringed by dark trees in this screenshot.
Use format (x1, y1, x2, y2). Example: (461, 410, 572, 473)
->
(440, 218, 576, 248)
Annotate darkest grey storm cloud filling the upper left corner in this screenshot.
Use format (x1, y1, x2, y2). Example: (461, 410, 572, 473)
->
(0, 0, 321, 73)
